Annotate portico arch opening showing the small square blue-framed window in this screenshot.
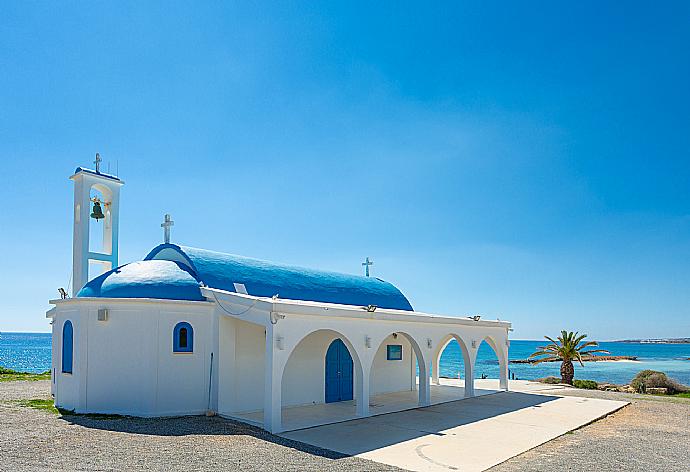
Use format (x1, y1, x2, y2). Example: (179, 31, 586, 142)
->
(369, 332, 429, 413)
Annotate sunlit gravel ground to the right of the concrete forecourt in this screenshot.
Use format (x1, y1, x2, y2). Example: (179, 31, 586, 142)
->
(491, 390, 690, 472)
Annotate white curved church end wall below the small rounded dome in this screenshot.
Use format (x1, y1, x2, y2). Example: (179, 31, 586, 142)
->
(53, 300, 213, 416)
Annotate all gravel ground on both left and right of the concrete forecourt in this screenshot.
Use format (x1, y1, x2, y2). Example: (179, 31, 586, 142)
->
(0, 381, 690, 472)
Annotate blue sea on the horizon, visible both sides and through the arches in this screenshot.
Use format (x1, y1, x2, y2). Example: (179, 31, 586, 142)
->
(0, 332, 690, 385)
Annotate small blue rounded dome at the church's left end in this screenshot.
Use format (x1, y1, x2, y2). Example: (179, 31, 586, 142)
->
(77, 261, 205, 301)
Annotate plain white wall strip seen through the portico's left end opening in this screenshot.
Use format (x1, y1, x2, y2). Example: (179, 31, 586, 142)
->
(233, 320, 266, 412)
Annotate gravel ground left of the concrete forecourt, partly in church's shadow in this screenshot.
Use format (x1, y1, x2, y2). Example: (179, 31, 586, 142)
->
(0, 381, 400, 472)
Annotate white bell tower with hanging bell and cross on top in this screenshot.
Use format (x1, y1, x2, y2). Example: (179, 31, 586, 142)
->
(70, 153, 124, 296)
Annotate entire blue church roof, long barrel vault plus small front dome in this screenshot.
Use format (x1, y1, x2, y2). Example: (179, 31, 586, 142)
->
(77, 244, 412, 311)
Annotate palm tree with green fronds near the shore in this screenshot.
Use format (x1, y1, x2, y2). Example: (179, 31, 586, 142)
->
(529, 330, 609, 385)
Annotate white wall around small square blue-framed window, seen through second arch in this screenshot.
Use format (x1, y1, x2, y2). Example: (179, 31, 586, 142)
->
(369, 335, 412, 395)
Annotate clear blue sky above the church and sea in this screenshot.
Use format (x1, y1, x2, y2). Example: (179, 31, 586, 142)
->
(0, 2, 690, 339)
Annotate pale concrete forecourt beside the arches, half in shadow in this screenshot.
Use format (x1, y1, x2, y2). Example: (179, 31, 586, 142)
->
(282, 381, 627, 471)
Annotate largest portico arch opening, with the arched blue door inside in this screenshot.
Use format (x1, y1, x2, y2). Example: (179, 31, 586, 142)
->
(281, 329, 362, 429)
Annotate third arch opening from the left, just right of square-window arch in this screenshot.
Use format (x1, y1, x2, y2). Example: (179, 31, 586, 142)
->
(432, 334, 474, 400)
